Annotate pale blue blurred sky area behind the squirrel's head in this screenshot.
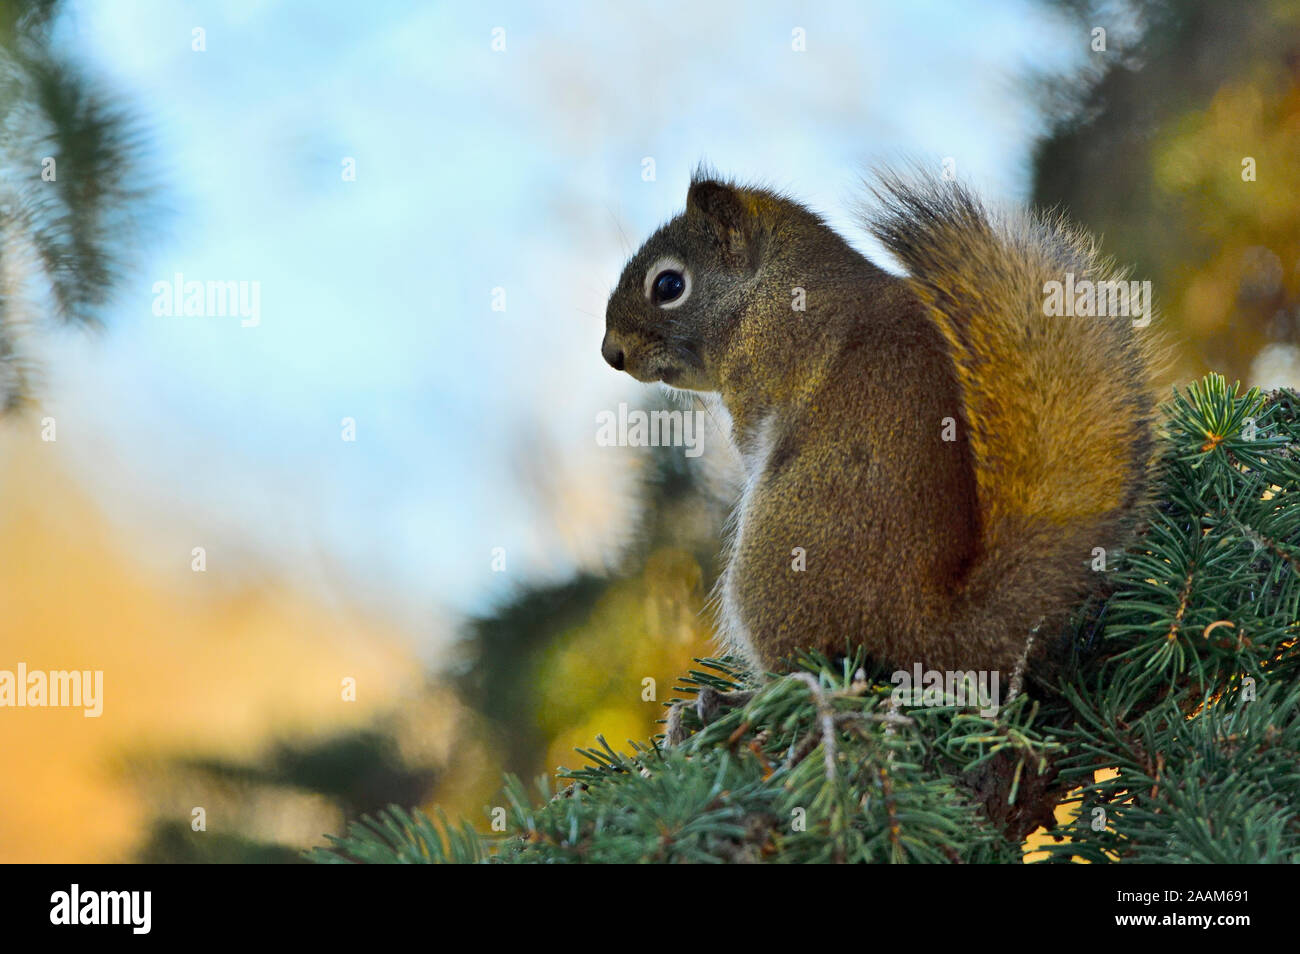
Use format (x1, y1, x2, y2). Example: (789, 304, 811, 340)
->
(46, 0, 1088, 655)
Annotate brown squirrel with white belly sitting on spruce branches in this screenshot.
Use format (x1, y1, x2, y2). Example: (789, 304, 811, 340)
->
(601, 170, 1157, 685)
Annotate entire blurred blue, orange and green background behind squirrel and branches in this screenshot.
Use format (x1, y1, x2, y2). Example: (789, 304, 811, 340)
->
(0, 0, 1300, 862)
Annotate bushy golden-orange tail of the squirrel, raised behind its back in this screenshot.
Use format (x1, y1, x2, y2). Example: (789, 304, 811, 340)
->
(867, 172, 1156, 665)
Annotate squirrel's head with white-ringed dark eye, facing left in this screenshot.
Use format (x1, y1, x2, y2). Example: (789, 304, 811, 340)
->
(601, 178, 780, 391)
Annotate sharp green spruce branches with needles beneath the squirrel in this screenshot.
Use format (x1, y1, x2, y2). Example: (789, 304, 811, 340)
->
(309, 374, 1300, 863)
